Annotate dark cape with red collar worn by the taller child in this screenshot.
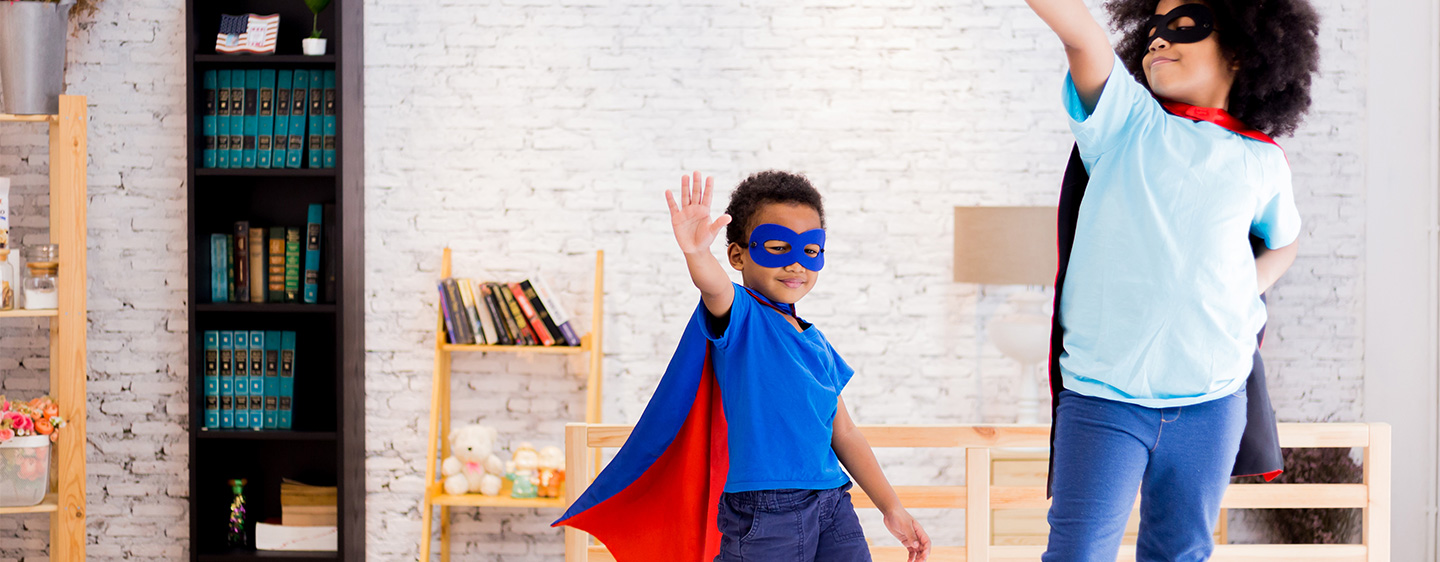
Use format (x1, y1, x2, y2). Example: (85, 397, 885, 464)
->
(1047, 101, 1284, 495)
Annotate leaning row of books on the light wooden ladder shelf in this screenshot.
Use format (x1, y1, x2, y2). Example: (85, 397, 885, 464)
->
(439, 277, 580, 346)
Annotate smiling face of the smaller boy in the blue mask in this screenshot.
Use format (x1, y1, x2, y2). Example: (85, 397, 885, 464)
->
(726, 203, 821, 303)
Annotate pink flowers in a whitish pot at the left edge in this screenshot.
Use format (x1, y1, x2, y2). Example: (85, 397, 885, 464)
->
(0, 396, 65, 507)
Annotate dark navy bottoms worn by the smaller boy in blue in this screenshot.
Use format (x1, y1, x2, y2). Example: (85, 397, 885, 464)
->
(714, 483, 870, 562)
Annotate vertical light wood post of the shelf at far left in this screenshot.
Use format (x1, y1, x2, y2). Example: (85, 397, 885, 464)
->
(50, 95, 89, 562)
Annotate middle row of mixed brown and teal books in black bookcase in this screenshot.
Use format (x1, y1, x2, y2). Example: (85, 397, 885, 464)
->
(210, 205, 336, 304)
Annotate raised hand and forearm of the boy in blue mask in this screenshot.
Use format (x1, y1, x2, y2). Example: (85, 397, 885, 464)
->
(665, 171, 734, 317)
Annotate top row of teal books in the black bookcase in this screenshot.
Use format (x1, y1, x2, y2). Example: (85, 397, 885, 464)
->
(200, 69, 336, 169)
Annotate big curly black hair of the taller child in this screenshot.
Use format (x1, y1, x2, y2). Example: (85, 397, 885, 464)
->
(1104, 0, 1320, 137)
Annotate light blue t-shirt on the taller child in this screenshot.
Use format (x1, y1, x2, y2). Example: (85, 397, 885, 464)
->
(1060, 58, 1300, 408)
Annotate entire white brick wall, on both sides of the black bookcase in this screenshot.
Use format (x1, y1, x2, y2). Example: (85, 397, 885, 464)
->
(0, 0, 1367, 561)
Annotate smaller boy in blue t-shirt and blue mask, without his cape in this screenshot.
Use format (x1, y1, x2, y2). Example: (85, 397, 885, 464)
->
(665, 171, 930, 562)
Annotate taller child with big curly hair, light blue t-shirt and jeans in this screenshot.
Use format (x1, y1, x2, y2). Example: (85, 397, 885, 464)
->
(1027, 0, 1319, 562)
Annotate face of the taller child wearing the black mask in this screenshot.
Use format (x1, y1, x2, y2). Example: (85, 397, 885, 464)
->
(1142, 0, 1236, 110)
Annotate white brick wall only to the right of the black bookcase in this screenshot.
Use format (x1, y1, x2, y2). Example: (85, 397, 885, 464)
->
(366, 0, 1365, 561)
